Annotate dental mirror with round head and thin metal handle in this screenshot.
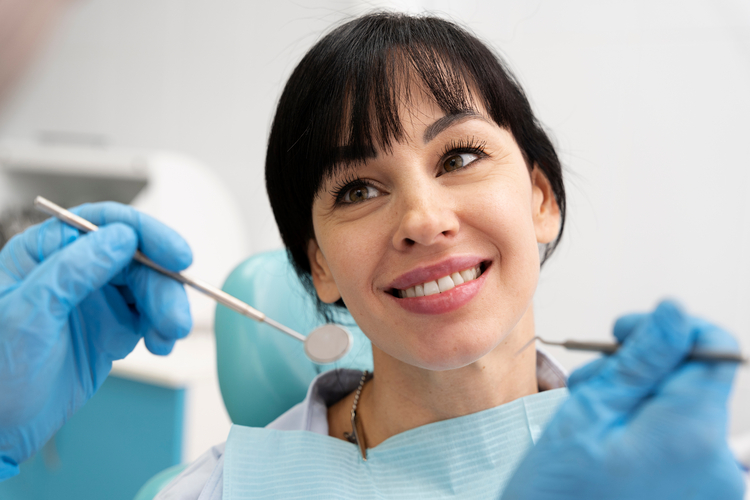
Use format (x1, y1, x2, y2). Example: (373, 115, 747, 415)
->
(34, 196, 353, 364)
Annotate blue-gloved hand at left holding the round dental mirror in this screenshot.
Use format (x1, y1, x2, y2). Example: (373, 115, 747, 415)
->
(0, 203, 192, 480)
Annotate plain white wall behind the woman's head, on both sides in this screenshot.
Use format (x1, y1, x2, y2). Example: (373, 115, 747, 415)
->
(0, 0, 750, 432)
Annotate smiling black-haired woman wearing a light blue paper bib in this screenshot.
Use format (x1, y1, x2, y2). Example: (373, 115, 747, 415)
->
(158, 13, 748, 499)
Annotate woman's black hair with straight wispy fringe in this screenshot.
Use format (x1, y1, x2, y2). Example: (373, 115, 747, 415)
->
(266, 12, 566, 318)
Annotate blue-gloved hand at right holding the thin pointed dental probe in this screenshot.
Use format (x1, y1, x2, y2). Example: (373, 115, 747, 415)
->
(502, 302, 744, 500)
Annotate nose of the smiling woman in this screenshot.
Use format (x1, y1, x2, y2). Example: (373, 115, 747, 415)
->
(393, 182, 459, 250)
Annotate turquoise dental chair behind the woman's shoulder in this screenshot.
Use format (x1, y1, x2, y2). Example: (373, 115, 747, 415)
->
(134, 250, 372, 500)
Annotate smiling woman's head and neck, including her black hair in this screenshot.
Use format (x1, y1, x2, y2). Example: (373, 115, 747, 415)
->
(266, 7, 565, 458)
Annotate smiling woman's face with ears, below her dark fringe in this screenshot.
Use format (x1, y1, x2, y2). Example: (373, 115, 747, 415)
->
(309, 92, 560, 370)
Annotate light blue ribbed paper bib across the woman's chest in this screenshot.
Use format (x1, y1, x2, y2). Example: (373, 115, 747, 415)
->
(223, 389, 568, 500)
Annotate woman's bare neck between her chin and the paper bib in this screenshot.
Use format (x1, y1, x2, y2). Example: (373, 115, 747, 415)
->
(354, 307, 538, 448)
